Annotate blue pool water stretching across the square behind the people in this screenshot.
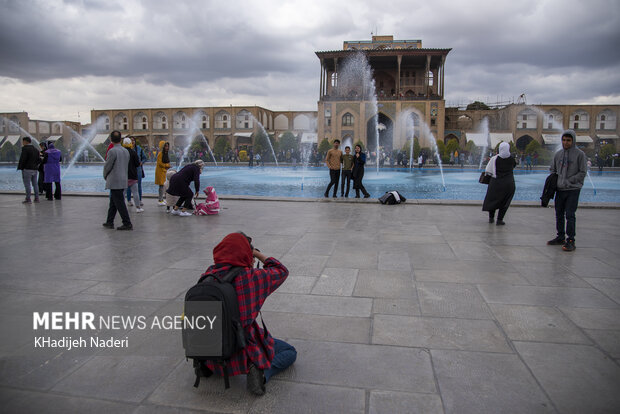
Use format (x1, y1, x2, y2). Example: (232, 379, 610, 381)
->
(0, 165, 620, 203)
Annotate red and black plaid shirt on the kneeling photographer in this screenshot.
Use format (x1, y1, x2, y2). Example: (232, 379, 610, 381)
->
(204, 257, 288, 376)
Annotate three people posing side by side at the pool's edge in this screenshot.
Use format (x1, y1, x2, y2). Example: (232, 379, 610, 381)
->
(324, 139, 370, 198)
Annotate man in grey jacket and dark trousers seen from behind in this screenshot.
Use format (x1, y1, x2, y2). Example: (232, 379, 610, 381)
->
(103, 130, 133, 230)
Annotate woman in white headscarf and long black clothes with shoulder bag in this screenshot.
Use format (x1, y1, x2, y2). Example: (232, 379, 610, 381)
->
(482, 142, 517, 226)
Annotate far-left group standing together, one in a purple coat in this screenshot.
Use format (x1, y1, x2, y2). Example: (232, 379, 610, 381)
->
(17, 137, 62, 204)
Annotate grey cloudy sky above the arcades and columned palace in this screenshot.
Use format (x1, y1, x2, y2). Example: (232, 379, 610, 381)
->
(0, 0, 620, 123)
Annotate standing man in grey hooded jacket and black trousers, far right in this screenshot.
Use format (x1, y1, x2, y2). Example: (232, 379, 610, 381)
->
(547, 129, 588, 252)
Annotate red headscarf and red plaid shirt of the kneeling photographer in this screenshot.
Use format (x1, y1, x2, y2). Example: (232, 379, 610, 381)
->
(203, 233, 288, 376)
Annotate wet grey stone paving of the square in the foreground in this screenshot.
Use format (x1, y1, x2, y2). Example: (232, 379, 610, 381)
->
(0, 195, 620, 414)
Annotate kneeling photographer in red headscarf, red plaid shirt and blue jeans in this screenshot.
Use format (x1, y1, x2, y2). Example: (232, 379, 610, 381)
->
(201, 232, 297, 395)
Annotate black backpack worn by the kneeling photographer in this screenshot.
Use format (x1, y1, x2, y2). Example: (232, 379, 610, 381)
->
(182, 267, 246, 389)
